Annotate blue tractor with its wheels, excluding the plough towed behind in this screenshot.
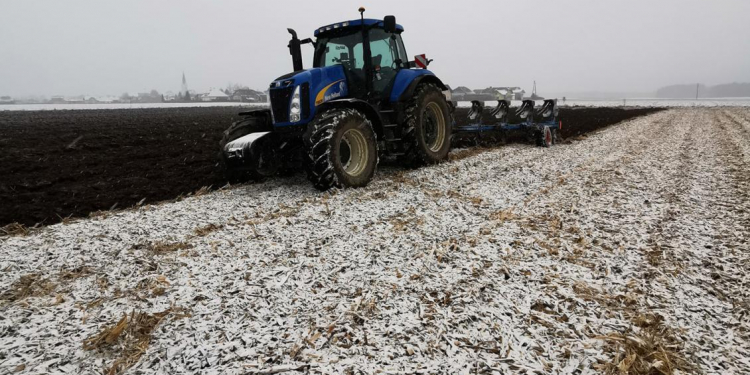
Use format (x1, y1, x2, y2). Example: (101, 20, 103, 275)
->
(220, 8, 453, 190)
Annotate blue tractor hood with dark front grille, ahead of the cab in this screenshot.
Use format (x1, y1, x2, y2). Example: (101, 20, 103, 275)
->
(269, 65, 349, 126)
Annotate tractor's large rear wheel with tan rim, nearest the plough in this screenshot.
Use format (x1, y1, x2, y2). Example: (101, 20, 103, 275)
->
(403, 83, 453, 166)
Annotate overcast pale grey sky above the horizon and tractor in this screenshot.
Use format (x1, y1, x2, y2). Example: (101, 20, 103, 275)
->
(0, 0, 750, 96)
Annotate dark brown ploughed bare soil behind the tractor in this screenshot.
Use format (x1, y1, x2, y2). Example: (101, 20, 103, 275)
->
(0, 107, 657, 226)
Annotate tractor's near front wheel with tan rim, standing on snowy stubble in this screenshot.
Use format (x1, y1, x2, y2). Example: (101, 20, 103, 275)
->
(305, 108, 378, 191)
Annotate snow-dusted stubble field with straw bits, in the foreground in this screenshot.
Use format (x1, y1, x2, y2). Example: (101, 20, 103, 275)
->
(0, 108, 750, 374)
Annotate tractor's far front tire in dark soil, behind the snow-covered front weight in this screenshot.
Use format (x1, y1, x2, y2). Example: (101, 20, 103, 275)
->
(219, 116, 279, 183)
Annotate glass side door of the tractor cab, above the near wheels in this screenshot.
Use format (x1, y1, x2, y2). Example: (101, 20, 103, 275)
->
(369, 28, 408, 102)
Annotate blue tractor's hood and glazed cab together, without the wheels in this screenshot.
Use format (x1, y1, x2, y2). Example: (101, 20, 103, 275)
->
(269, 9, 447, 133)
